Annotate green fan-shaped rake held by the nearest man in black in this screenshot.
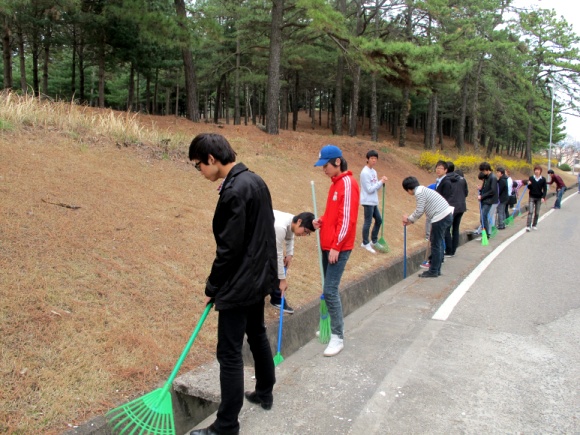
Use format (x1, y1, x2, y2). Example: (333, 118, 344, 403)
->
(107, 303, 213, 435)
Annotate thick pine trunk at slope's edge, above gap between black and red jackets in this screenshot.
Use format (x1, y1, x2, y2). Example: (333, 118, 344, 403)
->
(266, 0, 284, 134)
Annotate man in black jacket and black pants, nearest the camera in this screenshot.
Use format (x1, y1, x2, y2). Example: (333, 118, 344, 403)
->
(189, 133, 278, 435)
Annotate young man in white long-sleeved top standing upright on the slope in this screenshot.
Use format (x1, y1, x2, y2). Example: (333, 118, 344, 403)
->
(360, 150, 388, 254)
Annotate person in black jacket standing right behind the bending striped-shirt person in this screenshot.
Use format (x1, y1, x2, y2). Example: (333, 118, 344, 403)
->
(436, 161, 469, 257)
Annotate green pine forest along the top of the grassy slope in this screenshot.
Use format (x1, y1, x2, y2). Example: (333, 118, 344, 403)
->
(0, 0, 580, 163)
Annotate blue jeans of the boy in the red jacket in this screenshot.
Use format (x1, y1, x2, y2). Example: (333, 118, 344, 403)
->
(322, 251, 351, 338)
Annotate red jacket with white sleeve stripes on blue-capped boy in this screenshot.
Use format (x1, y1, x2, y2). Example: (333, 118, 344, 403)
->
(320, 171, 360, 251)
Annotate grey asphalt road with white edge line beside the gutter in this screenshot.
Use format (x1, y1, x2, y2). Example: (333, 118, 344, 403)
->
(189, 192, 580, 435)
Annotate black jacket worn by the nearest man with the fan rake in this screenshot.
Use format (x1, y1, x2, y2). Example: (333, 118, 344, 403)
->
(205, 163, 278, 310)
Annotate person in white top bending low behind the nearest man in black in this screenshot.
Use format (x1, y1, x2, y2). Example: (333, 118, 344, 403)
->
(270, 210, 315, 314)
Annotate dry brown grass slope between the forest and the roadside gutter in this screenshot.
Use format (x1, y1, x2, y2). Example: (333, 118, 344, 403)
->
(0, 94, 572, 434)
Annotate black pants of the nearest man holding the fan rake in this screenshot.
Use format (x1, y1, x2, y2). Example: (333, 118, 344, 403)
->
(213, 300, 276, 434)
